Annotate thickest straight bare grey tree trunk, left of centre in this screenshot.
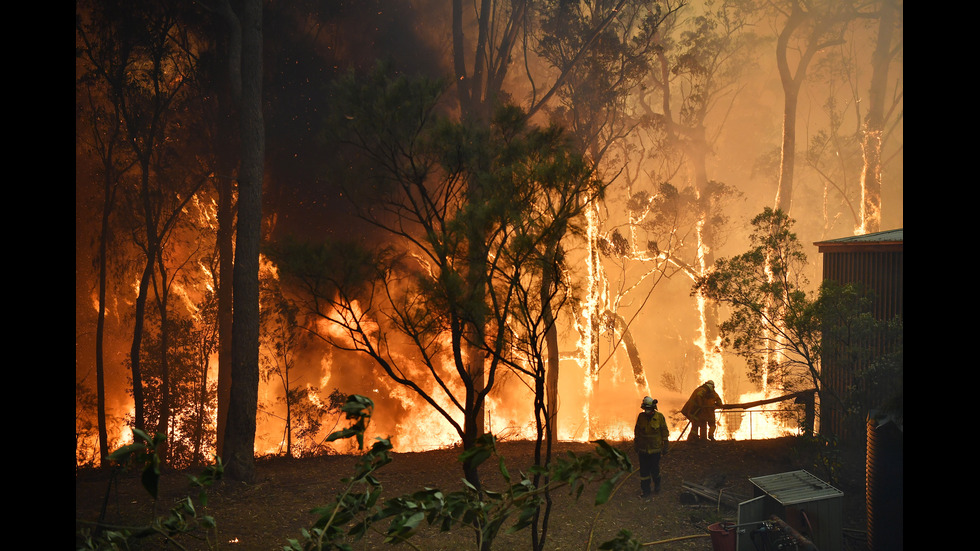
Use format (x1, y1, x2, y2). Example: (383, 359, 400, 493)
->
(224, 0, 265, 481)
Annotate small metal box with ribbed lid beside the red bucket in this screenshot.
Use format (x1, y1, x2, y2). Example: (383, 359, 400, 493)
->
(736, 470, 844, 551)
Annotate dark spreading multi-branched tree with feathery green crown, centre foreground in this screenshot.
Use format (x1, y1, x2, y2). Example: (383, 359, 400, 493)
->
(272, 67, 601, 492)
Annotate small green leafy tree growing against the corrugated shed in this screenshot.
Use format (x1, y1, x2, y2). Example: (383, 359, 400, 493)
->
(694, 208, 903, 415)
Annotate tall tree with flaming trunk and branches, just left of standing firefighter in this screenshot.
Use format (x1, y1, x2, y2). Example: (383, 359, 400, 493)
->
(532, 1, 682, 437)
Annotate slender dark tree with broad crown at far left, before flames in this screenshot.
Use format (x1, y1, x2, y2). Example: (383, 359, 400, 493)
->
(82, 2, 202, 440)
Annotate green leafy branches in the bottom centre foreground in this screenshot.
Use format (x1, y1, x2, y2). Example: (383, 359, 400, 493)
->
(284, 395, 632, 551)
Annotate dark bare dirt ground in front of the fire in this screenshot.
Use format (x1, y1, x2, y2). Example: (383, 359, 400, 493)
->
(75, 437, 866, 551)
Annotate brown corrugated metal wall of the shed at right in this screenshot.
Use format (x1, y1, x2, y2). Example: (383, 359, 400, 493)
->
(820, 248, 905, 438)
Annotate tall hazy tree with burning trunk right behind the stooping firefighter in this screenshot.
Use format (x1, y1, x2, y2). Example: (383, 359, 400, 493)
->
(642, 1, 761, 398)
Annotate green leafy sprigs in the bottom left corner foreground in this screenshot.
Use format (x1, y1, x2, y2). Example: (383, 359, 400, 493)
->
(76, 429, 224, 551)
